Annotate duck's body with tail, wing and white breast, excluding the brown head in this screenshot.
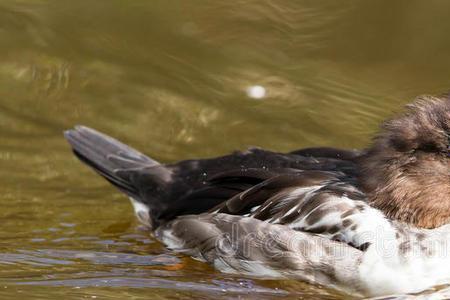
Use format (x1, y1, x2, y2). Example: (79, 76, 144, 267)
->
(65, 95, 450, 296)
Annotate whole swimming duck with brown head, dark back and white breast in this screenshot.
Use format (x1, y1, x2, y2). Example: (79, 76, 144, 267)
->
(64, 96, 450, 297)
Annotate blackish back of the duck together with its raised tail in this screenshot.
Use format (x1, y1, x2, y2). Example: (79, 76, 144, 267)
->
(65, 126, 356, 228)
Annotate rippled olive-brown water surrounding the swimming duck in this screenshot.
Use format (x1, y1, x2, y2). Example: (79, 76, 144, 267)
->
(0, 0, 450, 299)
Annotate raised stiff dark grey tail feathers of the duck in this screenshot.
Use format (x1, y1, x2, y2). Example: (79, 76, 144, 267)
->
(64, 126, 159, 196)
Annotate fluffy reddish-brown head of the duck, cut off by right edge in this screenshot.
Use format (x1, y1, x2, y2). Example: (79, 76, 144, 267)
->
(359, 96, 450, 228)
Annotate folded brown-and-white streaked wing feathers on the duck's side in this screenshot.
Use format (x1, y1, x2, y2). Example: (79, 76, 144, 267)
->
(211, 169, 395, 250)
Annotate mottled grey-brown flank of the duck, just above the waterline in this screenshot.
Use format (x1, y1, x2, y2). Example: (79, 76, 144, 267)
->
(156, 214, 363, 293)
